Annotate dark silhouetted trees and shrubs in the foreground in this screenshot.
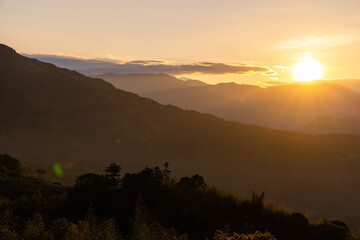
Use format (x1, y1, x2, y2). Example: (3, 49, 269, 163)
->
(0, 155, 358, 240)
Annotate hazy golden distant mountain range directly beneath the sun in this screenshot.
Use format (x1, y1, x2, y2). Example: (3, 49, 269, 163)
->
(95, 74, 360, 131)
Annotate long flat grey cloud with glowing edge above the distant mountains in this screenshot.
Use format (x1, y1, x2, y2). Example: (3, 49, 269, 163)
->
(23, 54, 272, 75)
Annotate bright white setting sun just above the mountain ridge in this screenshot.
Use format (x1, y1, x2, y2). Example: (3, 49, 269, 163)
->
(292, 55, 323, 82)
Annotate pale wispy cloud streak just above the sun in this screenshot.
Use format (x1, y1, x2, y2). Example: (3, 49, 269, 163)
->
(273, 32, 360, 50)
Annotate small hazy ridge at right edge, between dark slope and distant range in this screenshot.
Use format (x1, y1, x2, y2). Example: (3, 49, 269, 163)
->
(303, 114, 360, 135)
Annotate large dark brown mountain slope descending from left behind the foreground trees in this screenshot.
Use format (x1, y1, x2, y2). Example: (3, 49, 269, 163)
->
(0, 45, 360, 228)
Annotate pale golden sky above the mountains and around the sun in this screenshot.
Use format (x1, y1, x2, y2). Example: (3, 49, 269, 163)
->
(0, 0, 360, 83)
